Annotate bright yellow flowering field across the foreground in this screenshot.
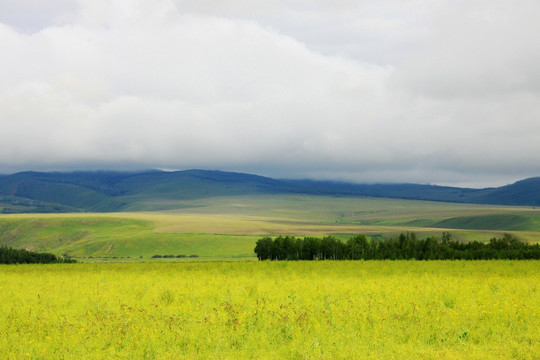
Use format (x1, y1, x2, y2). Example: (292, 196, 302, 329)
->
(0, 261, 540, 359)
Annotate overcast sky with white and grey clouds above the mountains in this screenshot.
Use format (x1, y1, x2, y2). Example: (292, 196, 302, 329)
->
(0, 0, 540, 187)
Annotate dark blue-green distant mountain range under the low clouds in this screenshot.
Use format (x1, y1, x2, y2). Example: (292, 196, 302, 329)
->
(0, 170, 540, 213)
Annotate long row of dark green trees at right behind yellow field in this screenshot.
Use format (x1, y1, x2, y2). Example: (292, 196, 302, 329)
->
(255, 232, 540, 260)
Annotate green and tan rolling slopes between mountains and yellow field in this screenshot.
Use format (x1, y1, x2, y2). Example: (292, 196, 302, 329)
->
(0, 195, 540, 261)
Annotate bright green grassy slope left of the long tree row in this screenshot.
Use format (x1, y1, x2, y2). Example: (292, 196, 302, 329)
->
(0, 214, 257, 259)
